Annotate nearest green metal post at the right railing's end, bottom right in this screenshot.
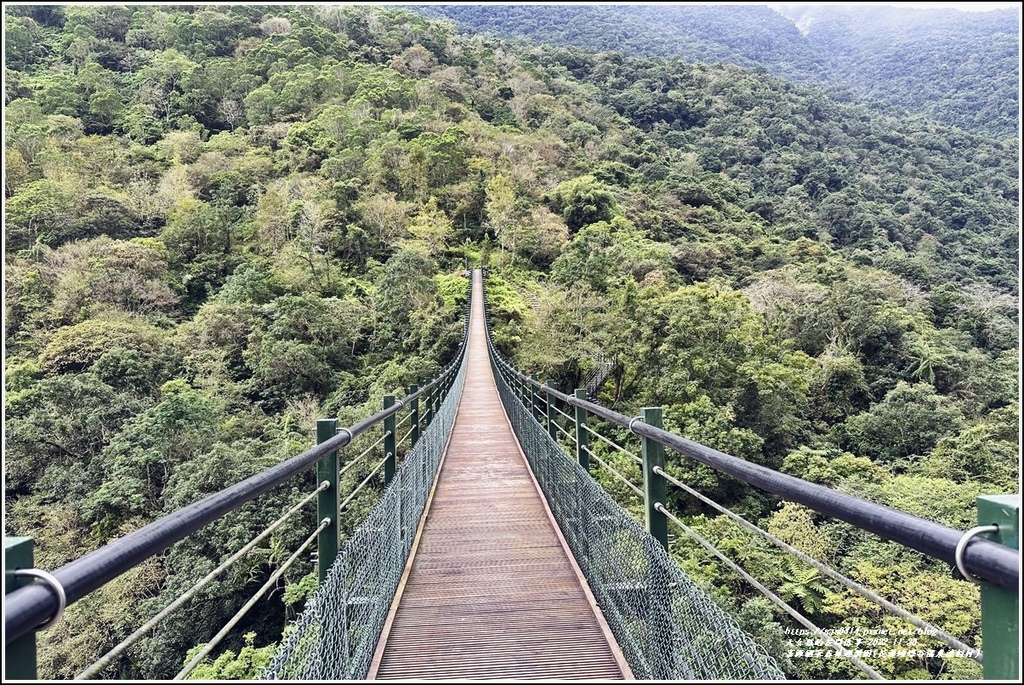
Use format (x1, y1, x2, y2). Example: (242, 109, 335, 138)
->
(977, 495, 1021, 682)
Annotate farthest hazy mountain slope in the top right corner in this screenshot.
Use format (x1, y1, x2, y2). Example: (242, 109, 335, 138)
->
(779, 5, 1021, 137)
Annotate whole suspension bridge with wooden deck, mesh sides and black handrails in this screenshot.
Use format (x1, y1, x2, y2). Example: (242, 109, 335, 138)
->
(4, 270, 1020, 680)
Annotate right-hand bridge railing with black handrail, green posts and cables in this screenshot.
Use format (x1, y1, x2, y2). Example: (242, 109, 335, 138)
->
(487, 270, 1020, 679)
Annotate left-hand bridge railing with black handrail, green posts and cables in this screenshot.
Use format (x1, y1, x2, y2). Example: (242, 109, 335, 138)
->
(3, 274, 472, 680)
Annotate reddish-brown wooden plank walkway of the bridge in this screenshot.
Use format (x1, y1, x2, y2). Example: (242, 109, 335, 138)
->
(369, 271, 631, 680)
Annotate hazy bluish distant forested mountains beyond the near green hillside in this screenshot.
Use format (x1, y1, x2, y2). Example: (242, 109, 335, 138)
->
(416, 3, 1020, 138)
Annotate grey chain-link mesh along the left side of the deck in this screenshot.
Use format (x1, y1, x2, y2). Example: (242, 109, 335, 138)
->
(261, 358, 466, 681)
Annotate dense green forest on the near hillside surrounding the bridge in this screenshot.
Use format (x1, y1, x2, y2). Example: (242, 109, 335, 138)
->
(4, 5, 1020, 679)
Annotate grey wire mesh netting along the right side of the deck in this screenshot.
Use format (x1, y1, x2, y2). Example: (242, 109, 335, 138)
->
(496, 362, 785, 680)
